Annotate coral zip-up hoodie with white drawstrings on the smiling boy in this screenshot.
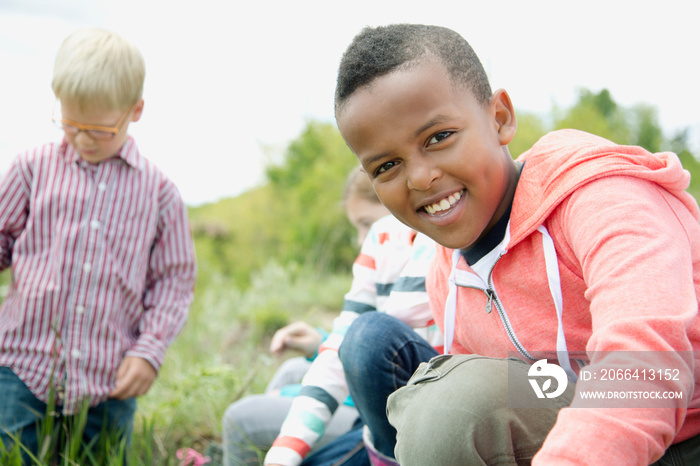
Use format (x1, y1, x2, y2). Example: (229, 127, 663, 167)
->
(427, 130, 700, 465)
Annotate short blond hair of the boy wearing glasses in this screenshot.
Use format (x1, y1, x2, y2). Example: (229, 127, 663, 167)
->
(51, 28, 146, 110)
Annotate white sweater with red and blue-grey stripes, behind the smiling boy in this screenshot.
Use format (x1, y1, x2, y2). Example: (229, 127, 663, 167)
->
(265, 216, 442, 465)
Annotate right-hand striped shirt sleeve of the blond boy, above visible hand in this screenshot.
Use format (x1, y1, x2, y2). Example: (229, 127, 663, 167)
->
(126, 187, 197, 370)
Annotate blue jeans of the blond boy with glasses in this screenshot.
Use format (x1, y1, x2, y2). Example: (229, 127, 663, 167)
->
(0, 367, 136, 462)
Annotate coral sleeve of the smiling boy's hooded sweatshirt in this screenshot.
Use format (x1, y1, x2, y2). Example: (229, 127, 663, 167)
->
(533, 177, 700, 466)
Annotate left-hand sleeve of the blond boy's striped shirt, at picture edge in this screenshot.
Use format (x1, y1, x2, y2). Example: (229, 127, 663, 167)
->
(0, 156, 32, 270)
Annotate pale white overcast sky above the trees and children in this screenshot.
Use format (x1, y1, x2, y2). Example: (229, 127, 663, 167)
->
(0, 0, 700, 205)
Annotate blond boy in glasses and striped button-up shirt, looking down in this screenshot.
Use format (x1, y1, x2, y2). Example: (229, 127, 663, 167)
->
(0, 29, 196, 460)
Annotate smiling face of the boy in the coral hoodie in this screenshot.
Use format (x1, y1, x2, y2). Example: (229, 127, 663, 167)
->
(337, 58, 518, 249)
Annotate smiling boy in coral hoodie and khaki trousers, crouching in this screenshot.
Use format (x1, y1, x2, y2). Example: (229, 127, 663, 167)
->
(335, 25, 700, 465)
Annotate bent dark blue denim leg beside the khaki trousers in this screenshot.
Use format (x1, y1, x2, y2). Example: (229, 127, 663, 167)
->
(339, 312, 438, 458)
